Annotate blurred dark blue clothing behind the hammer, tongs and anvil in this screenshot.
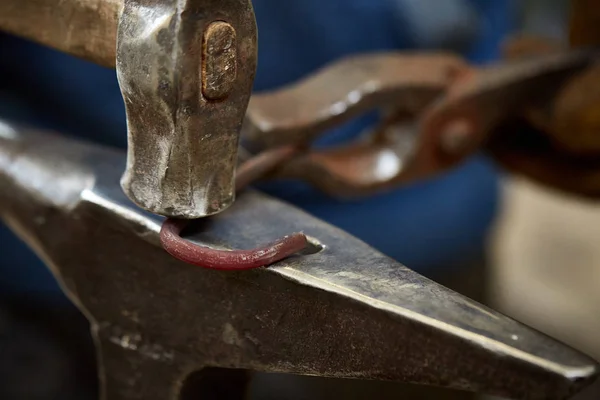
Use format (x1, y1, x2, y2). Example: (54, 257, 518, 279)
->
(0, 0, 511, 293)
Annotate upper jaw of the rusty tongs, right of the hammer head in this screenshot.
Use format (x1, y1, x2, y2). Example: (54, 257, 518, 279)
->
(244, 52, 467, 148)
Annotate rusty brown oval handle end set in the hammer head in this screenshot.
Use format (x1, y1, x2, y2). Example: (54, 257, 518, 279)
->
(202, 21, 237, 100)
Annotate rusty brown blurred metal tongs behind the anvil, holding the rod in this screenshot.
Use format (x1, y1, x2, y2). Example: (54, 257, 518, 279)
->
(240, 50, 596, 197)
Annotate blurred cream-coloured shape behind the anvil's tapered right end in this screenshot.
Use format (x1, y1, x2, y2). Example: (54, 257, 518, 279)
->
(490, 179, 600, 359)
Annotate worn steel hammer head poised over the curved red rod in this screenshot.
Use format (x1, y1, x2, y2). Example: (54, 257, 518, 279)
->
(117, 0, 257, 219)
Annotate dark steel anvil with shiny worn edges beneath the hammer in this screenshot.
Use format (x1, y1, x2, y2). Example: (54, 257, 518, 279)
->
(0, 124, 598, 400)
